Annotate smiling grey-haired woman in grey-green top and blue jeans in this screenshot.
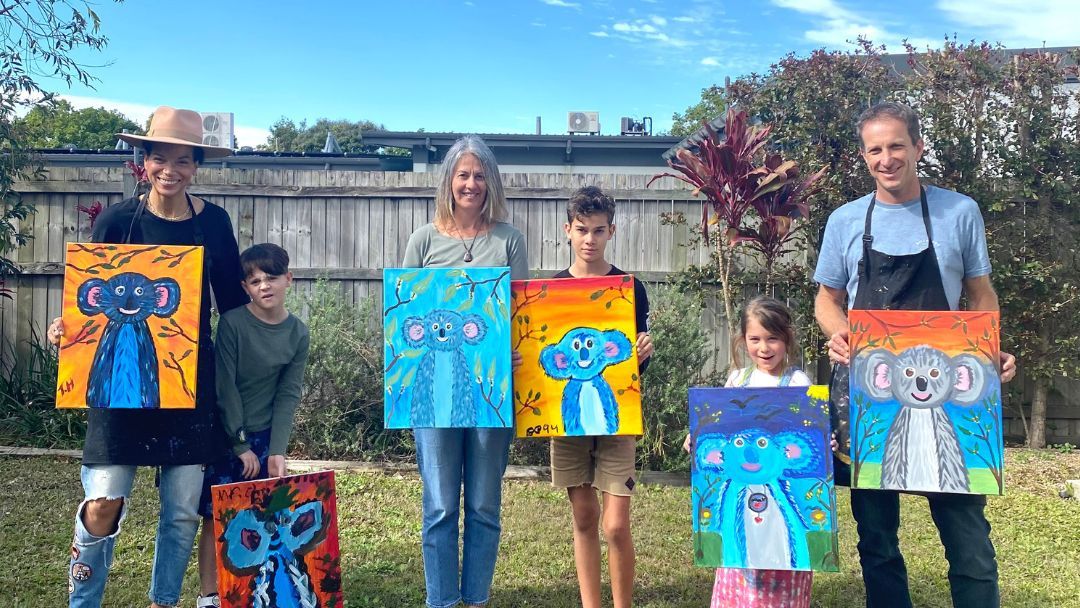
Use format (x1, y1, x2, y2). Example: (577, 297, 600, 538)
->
(404, 135, 528, 608)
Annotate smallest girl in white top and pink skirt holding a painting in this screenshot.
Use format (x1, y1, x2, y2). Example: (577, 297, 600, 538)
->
(684, 296, 812, 608)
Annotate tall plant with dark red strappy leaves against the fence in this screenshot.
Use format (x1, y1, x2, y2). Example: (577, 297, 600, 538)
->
(649, 109, 825, 335)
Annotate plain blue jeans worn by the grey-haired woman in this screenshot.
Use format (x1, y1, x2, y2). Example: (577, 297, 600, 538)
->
(414, 429, 514, 608)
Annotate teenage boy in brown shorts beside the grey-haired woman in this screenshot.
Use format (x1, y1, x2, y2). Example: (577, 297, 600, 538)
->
(551, 186, 652, 608)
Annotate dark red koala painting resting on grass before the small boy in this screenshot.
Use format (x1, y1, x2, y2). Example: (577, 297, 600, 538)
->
(211, 471, 342, 608)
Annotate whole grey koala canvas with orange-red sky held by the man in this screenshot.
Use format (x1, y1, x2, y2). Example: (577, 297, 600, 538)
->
(849, 310, 1004, 495)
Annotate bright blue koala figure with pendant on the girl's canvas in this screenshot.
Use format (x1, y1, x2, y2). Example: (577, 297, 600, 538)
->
(694, 428, 822, 569)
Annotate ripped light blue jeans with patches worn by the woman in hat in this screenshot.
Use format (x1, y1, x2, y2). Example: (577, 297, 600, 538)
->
(68, 464, 203, 608)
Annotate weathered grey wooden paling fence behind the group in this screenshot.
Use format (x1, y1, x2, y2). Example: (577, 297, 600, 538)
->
(0, 167, 1080, 443)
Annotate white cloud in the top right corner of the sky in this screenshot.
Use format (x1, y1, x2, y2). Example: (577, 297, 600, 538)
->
(937, 0, 1080, 48)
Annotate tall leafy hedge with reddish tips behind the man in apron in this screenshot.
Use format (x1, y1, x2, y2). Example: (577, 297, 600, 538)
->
(673, 40, 1080, 446)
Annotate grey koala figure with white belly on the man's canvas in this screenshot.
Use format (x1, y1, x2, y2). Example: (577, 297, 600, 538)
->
(853, 344, 997, 494)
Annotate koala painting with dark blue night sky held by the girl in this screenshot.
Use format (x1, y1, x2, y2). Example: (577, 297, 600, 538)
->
(690, 387, 839, 572)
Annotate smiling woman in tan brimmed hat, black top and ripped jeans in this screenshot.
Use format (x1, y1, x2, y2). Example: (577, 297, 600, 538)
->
(49, 106, 247, 608)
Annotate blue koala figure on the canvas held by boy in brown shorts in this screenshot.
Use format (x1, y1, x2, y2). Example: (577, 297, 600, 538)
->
(540, 327, 633, 435)
